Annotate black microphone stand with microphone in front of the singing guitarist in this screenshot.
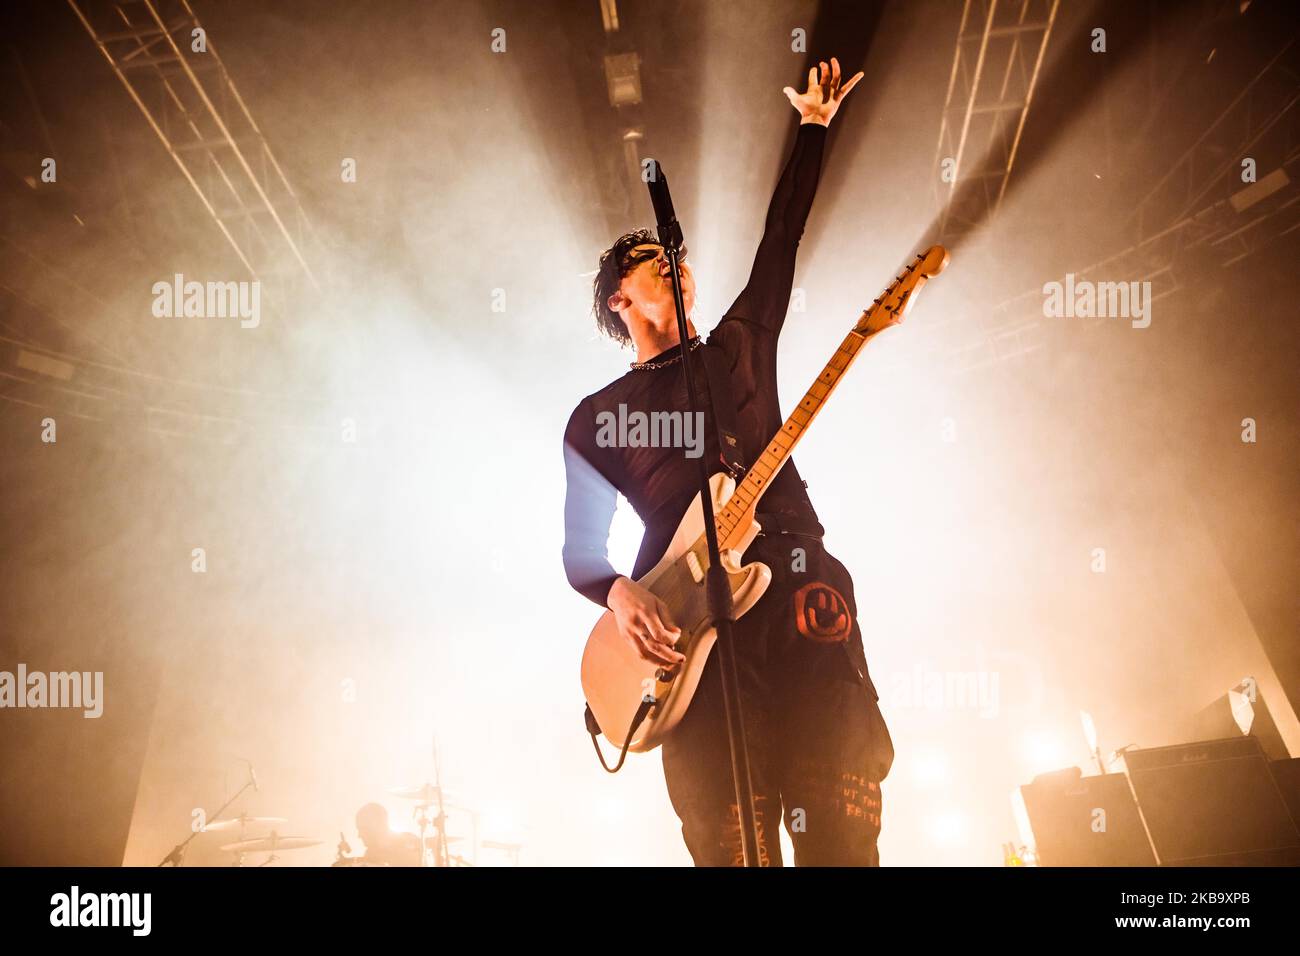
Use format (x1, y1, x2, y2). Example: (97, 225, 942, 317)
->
(647, 160, 761, 866)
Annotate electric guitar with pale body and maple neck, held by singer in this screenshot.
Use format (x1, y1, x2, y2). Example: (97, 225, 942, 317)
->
(582, 246, 948, 752)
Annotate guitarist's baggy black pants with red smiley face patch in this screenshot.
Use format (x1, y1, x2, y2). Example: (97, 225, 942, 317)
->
(663, 535, 893, 866)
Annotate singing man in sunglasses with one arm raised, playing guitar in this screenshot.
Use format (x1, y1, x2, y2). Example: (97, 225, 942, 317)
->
(564, 59, 893, 866)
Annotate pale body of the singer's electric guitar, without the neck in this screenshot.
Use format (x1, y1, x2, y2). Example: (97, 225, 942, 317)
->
(582, 473, 772, 753)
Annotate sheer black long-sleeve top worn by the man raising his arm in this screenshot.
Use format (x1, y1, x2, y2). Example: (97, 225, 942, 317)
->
(564, 124, 826, 606)
